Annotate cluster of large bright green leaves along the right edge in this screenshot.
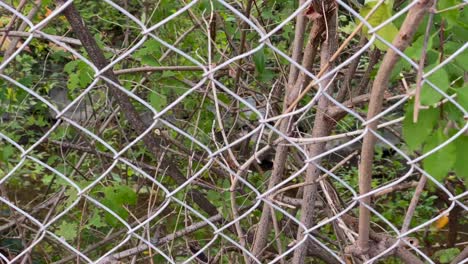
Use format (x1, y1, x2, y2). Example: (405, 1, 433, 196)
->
(394, 0, 468, 186)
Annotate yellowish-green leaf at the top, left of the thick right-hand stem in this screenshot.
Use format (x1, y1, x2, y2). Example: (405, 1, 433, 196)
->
(360, 1, 398, 51)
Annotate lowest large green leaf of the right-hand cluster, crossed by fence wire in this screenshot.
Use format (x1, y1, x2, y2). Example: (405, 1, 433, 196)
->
(422, 129, 456, 181)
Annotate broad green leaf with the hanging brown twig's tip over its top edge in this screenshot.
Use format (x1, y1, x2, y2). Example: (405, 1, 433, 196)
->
(403, 102, 439, 151)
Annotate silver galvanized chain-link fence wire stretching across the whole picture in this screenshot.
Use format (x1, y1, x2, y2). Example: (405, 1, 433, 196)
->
(0, 0, 468, 263)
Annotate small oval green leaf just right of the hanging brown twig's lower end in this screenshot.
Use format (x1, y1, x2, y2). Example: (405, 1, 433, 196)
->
(421, 65, 450, 105)
